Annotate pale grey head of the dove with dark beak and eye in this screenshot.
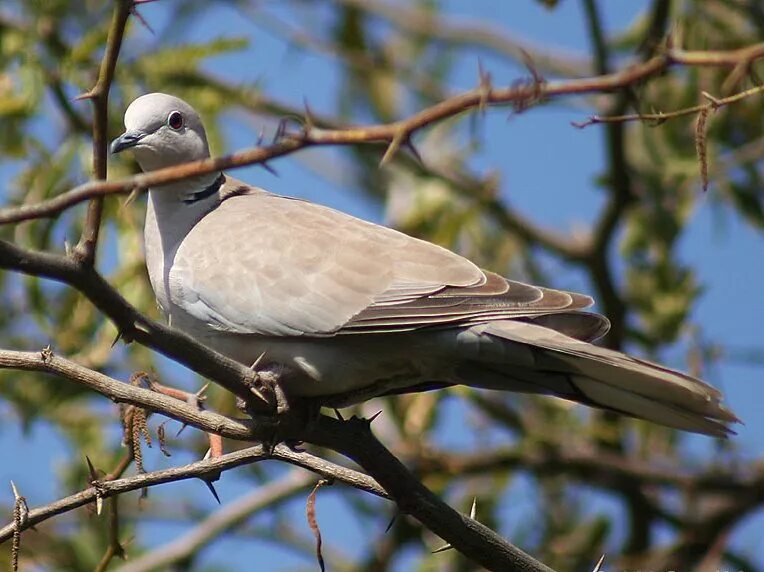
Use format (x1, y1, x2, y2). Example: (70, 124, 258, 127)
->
(111, 93, 210, 171)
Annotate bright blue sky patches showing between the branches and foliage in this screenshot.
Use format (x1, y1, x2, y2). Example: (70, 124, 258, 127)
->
(0, 0, 764, 570)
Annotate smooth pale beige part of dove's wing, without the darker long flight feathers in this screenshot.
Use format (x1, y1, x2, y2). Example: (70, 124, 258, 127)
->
(169, 180, 486, 336)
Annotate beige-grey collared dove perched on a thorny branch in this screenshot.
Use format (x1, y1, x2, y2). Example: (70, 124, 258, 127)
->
(110, 93, 739, 437)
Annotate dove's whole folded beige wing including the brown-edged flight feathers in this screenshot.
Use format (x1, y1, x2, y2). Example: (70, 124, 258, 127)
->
(170, 179, 608, 340)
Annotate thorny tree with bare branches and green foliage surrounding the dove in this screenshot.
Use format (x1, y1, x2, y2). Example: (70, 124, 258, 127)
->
(0, 0, 764, 570)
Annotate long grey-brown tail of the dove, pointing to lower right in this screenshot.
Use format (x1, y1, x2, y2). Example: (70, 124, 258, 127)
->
(457, 320, 739, 437)
